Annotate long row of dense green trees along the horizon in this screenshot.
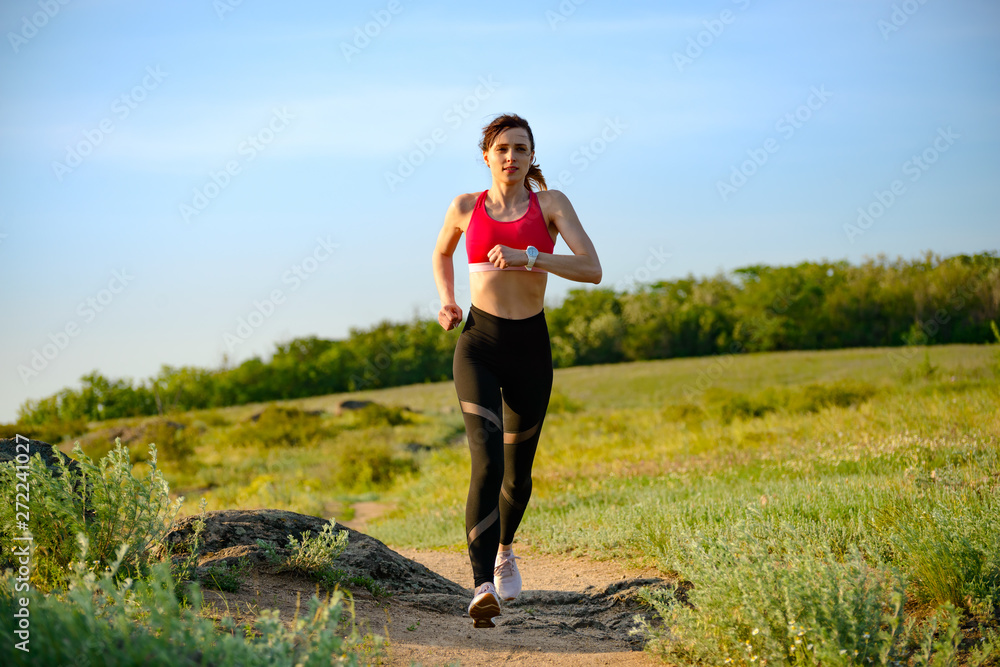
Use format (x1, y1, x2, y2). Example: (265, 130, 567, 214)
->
(18, 252, 1000, 426)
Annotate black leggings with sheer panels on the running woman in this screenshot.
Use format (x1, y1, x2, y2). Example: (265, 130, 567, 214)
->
(454, 306, 552, 588)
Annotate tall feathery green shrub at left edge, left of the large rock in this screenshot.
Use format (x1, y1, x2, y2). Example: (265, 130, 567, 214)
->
(0, 439, 181, 590)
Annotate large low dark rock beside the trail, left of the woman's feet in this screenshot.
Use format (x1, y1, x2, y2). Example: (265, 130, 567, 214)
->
(166, 509, 466, 596)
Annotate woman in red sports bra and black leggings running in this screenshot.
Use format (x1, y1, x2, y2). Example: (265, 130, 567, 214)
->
(432, 115, 601, 628)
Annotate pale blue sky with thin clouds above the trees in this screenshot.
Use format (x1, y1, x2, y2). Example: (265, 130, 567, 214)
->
(0, 0, 1000, 421)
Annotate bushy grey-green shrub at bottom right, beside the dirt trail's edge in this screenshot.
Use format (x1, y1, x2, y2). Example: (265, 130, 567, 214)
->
(644, 524, 903, 665)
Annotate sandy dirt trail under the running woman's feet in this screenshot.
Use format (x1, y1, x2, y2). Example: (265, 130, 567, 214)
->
(357, 549, 665, 667)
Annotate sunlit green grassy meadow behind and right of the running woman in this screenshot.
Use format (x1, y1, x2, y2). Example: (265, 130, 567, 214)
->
(31, 346, 1000, 665)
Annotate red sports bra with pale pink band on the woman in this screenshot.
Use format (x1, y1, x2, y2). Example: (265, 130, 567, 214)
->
(465, 190, 556, 273)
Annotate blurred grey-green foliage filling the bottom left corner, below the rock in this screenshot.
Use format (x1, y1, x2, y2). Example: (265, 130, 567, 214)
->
(0, 539, 383, 667)
